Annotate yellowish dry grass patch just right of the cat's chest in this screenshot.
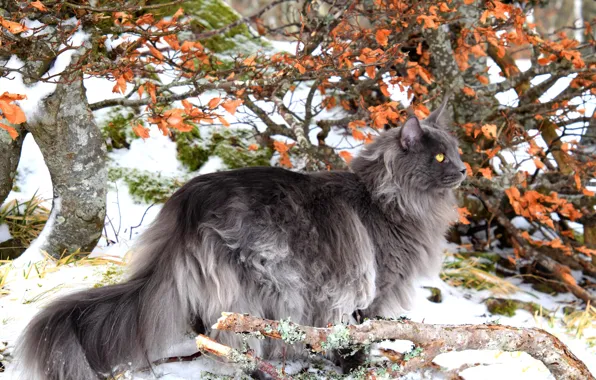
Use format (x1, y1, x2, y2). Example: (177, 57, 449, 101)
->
(441, 253, 520, 295)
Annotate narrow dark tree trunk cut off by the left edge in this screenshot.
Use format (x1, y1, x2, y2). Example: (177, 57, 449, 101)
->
(0, 124, 25, 205)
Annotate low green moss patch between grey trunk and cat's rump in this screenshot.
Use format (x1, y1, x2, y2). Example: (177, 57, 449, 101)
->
(108, 168, 186, 203)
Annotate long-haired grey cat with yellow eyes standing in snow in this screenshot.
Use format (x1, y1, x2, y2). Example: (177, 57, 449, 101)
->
(17, 97, 465, 380)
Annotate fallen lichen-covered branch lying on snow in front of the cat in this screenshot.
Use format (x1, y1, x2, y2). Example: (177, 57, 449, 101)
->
(212, 313, 594, 380)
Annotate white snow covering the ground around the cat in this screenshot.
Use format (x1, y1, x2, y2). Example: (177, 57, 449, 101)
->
(0, 129, 596, 379)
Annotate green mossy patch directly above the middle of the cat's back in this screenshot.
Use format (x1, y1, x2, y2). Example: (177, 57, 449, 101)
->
(176, 128, 273, 171)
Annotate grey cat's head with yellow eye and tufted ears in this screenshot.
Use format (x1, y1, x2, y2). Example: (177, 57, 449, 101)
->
(351, 96, 466, 197)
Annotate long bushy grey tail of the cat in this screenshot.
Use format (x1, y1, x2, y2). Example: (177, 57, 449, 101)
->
(16, 220, 189, 380)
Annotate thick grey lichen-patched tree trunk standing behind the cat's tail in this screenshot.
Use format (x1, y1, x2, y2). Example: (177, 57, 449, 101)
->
(28, 75, 107, 257)
